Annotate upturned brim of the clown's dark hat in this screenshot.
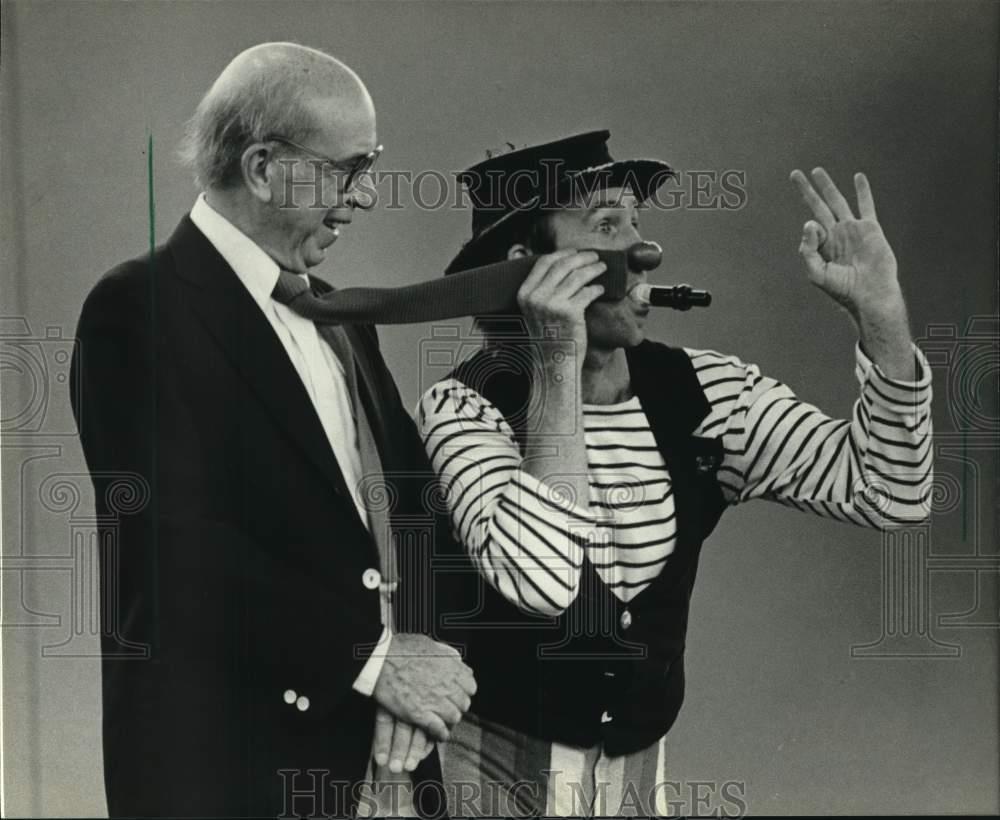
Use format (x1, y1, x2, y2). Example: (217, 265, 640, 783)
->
(444, 159, 674, 276)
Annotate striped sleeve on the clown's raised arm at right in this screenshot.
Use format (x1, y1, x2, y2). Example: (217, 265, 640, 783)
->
(688, 348, 933, 527)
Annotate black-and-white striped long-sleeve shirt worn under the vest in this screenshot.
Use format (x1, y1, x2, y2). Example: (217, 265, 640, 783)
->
(417, 346, 933, 614)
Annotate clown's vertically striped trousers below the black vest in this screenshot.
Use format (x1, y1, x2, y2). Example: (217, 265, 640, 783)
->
(439, 712, 669, 818)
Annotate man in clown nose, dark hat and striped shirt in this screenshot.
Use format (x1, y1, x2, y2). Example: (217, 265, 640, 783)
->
(418, 131, 932, 816)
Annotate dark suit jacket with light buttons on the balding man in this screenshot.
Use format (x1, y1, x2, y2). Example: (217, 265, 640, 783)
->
(71, 217, 447, 816)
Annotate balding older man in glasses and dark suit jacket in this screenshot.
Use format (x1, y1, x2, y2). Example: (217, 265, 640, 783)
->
(72, 43, 475, 817)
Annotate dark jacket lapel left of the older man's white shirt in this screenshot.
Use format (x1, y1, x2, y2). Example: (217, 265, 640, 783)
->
(168, 216, 360, 521)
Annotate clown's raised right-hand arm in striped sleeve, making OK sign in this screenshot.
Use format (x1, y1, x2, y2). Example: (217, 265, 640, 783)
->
(692, 168, 933, 526)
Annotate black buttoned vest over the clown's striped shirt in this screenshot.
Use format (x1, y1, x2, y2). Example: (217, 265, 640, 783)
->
(443, 341, 725, 755)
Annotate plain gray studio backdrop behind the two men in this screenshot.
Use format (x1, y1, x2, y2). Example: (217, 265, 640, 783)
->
(0, 2, 1000, 816)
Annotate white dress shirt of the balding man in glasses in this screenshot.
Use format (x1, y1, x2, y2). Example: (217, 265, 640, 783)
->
(191, 194, 392, 697)
